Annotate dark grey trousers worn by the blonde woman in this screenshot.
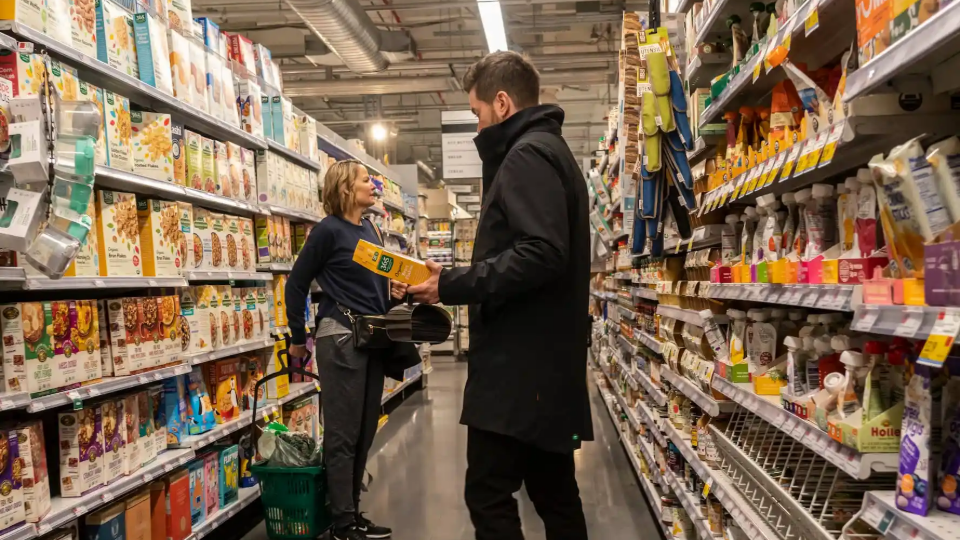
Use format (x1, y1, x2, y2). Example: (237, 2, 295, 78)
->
(316, 334, 383, 527)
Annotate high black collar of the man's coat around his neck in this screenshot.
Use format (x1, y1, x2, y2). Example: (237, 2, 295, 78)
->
(473, 105, 563, 193)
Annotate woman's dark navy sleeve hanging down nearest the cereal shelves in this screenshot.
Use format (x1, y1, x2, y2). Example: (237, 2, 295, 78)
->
(284, 222, 334, 345)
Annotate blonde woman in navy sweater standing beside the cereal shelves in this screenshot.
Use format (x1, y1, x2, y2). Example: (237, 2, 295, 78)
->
(285, 159, 406, 540)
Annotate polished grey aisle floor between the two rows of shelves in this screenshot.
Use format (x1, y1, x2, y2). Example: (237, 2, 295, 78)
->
(244, 363, 660, 540)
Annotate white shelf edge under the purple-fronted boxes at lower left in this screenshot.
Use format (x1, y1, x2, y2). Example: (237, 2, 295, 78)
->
(37, 449, 195, 535)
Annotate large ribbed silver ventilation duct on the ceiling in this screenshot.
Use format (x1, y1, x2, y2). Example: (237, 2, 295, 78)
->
(278, 0, 413, 75)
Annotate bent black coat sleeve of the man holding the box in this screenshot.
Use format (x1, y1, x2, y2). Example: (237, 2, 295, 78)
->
(439, 141, 570, 305)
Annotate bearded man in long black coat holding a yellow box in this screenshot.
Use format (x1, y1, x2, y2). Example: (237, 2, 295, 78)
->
(408, 52, 593, 540)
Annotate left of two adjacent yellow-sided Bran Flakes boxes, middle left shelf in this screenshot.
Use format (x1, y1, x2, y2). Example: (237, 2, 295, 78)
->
(97, 190, 143, 276)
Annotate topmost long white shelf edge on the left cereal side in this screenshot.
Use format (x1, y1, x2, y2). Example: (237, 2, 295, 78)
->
(0, 20, 267, 149)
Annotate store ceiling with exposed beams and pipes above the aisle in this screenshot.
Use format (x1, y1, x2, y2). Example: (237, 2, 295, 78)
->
(193, 0, 645, 171)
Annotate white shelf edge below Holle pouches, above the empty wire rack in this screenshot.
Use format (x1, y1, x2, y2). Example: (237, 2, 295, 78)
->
(712, 375, 899, 480)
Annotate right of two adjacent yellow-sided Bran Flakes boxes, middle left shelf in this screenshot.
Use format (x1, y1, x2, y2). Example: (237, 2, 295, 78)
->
(137, 199, 186, 277)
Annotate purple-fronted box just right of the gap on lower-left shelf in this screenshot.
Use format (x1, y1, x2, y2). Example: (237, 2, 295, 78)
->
(57, 407, 103, 497)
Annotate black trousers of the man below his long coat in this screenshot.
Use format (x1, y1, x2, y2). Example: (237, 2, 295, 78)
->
(465, 428, 587, 540)
